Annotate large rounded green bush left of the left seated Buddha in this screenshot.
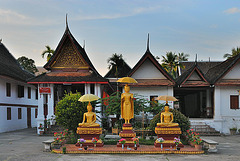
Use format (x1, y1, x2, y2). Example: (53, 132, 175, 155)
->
(56, 93, 87, 132)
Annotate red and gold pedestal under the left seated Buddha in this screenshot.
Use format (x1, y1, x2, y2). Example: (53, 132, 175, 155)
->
(77, 126, 103, 147)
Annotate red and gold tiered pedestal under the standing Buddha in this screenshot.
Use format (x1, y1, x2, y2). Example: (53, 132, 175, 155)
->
(117, 124, 139, 147)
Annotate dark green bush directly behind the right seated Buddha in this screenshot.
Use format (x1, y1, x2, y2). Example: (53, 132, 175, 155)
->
(150, 109, 190, 133)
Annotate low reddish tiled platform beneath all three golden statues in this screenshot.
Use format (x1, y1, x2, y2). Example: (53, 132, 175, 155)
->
(52, 144, 204, 154)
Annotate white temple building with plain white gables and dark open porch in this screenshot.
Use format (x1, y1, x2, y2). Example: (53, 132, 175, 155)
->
(106, 35, 240, 134)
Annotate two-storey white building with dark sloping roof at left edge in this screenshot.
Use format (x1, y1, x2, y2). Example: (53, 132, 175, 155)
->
(0, 42, 38, 133)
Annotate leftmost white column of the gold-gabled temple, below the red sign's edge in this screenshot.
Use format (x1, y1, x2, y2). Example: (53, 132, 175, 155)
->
(36, 84, 44, 134)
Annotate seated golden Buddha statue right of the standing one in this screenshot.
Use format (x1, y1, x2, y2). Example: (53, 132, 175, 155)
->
(157, 104, 178, 127)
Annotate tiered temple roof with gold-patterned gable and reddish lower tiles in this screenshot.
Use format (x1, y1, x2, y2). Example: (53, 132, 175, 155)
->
(29, 25, 108, 84)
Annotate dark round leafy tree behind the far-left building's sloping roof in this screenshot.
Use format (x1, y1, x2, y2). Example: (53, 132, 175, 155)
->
(17, 56, 38, 74)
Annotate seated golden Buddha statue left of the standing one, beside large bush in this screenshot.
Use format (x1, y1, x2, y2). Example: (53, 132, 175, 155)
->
(78, 102, 100, 127)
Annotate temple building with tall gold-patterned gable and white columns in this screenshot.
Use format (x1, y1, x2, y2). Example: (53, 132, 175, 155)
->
(28, 25, 108, 134)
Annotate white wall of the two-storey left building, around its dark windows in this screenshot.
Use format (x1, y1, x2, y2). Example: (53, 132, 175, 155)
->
(0, 76, 37, 132)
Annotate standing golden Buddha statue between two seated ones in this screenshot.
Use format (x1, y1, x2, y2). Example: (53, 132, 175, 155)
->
(121, 85, 134, 124)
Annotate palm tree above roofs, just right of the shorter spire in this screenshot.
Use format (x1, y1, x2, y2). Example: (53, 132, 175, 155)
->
(162, 52, 183, 78)
